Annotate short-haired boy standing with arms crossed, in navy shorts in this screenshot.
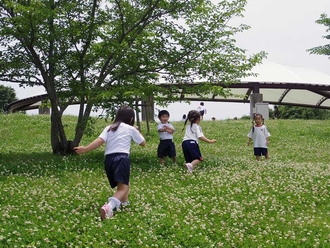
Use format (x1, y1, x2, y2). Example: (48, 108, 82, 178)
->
(157, 110, 176, 165)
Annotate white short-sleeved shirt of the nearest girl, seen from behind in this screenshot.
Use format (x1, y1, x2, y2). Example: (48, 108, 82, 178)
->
(99, 122, 144, 155)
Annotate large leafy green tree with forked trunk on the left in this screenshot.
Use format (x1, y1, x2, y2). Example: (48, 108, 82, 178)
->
(0, 0, 264, 154)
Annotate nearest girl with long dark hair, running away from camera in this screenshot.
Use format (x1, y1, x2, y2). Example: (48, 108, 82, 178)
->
(74, 106, 146, 220)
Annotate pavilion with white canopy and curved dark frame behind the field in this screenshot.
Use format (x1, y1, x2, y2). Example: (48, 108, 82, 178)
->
(7, 60, 330, 113)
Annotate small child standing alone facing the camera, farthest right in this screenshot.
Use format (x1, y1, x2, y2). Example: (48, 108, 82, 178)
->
(247, 114, 270, 161)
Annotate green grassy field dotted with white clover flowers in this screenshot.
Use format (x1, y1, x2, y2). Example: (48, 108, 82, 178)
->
(0, 114, 330, 247)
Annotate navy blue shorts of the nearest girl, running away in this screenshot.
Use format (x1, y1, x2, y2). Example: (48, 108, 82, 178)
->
(104, 153, 131, 188)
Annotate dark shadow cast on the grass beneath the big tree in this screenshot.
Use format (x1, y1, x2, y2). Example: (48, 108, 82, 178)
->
(0, 151, 164, 177)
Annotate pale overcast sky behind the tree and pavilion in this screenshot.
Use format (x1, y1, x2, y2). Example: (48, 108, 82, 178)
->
(2, 0, 330, 121)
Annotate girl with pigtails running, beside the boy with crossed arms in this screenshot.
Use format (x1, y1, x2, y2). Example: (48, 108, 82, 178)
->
(182, 110, 216, 174)
